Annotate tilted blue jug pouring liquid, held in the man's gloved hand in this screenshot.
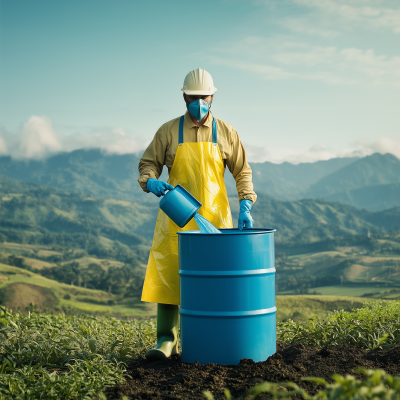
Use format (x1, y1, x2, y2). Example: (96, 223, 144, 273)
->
(160, 185, 202, 228)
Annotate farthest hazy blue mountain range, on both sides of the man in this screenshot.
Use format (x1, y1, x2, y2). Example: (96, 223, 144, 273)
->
(0, 150, 400, 211)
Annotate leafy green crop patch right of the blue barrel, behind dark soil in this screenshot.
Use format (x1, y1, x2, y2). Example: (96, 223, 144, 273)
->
(277, 301, 400, 350)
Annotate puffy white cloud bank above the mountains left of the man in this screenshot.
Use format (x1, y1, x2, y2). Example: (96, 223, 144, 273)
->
(0, 116, 143, 159)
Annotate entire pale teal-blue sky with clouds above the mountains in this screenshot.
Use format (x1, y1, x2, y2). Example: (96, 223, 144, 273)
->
(0, 0, 400, 163)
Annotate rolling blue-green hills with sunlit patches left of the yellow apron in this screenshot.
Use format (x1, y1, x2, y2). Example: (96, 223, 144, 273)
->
(0, 176, 157, 296)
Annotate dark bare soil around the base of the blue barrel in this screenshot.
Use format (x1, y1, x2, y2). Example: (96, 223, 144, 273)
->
(106, 344, 400, 399)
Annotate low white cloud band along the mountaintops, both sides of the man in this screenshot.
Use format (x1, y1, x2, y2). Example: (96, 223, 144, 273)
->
(0, 116, 400, 164)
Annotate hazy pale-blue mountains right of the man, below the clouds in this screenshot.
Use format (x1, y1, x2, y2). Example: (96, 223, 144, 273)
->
(226, 153, 400, 211)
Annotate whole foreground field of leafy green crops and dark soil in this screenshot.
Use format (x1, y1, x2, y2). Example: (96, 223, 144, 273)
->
(0, 301, 400, 400)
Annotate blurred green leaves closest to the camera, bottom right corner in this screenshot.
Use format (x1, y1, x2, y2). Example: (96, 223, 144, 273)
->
(203, 369, 400, 400)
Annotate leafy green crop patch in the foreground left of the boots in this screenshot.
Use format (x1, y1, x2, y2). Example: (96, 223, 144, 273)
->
(0, 307, 155, 399)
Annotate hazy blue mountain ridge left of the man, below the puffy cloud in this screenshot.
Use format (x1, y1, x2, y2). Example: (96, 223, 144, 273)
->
(0, 150, 148, 201)
